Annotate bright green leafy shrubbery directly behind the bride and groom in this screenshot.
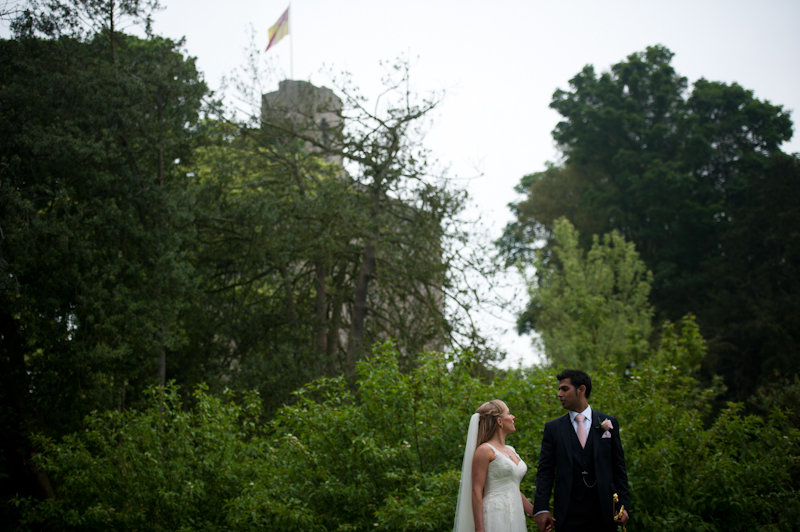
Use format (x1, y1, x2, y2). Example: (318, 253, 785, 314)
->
(15, 330, 800, 531)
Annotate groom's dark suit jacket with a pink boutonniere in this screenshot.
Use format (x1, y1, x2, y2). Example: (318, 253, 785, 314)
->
(533, 409, 630, 523)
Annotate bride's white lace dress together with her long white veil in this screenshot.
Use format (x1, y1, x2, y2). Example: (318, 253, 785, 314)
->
(453, 414, 528, 532)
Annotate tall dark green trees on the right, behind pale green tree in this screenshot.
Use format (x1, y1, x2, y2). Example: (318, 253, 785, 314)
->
(500, 47, 800, 400)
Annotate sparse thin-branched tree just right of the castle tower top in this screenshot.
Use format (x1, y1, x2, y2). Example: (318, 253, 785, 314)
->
(219, 57, 490, 375)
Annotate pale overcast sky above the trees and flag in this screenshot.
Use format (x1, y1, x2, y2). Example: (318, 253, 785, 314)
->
(2, 0, 800, 366)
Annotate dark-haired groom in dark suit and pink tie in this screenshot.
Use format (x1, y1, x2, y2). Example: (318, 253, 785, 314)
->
(533, 369, 630, 532)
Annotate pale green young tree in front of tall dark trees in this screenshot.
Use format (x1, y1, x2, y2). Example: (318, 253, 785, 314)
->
(518, 218, 653, 371)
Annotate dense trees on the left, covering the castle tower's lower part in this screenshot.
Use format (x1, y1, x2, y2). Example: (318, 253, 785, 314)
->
(0, 7, 484, 519)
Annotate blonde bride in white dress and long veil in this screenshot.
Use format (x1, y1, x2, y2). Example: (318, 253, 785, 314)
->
(453, 399, 533, 532)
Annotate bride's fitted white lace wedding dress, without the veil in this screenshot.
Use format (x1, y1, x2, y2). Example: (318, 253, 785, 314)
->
(483, 443, 528, 532)
